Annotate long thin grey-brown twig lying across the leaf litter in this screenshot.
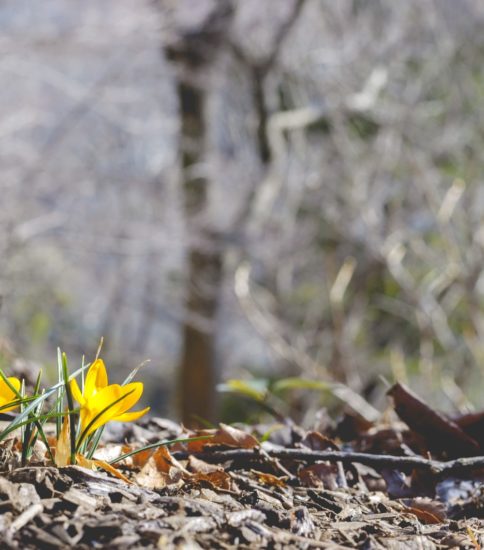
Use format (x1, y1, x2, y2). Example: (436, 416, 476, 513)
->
(173, 449, 484, 476)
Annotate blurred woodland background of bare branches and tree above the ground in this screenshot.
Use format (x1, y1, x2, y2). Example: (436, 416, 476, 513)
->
(0, 0, 484, 420)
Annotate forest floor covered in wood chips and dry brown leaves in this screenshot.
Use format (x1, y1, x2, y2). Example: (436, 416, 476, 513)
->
(0, 386, 484, 550)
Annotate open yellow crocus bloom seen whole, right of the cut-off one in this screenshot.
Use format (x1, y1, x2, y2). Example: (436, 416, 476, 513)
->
(71, 359, 150, 436)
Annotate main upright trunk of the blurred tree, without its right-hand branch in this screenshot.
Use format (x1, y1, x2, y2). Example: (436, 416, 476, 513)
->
(162, 0, 233, 424)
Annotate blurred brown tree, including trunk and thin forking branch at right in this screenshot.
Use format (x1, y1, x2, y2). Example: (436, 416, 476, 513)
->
(161, 0, 305, 423)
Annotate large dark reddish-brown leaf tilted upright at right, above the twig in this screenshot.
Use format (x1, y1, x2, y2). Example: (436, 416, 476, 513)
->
(388, 384, 480, 458)
